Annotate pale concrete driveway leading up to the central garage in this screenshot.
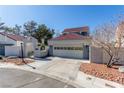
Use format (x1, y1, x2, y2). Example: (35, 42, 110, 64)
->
(37, 57, 82, 81)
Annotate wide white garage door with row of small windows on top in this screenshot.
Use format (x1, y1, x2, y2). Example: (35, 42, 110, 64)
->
(53, 47, 83, 59)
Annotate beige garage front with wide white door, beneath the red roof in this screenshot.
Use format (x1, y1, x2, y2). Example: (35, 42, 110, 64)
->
(49, 40, 90, 59)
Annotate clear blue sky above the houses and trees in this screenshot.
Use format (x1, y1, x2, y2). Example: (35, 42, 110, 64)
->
(0, 5, 124, 32)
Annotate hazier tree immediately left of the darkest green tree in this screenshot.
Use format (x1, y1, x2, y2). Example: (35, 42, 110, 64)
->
(23, 21, 37, 36)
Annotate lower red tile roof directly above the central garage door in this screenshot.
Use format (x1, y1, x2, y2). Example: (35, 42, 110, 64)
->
(51, 33, 91, 40)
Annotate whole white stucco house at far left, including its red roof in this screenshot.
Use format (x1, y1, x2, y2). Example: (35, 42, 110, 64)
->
(0, 32, 37, 57)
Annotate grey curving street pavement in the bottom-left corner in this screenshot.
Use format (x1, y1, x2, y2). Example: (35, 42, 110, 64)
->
(0, 68, 73, 88)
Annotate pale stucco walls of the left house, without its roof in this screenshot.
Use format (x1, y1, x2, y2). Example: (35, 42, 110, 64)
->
(0, 34, 37, 57)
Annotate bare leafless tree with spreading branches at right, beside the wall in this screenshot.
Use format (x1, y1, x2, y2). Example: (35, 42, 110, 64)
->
(93, 22, 124, 67)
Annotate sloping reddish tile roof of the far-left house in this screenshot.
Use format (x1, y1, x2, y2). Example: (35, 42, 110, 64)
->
(0, 32, 25, 41)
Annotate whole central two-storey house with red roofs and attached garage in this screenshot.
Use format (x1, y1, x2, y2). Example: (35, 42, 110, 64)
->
(48, 26, 91, 59)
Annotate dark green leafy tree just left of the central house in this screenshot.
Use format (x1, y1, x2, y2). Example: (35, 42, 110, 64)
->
(33, 24, 54, 45)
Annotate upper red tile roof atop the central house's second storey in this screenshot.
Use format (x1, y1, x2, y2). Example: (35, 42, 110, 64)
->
(63, 26, 89, 32)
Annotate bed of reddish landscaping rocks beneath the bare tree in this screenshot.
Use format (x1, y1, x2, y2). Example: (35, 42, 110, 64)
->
(80, 63, 124, 84)
